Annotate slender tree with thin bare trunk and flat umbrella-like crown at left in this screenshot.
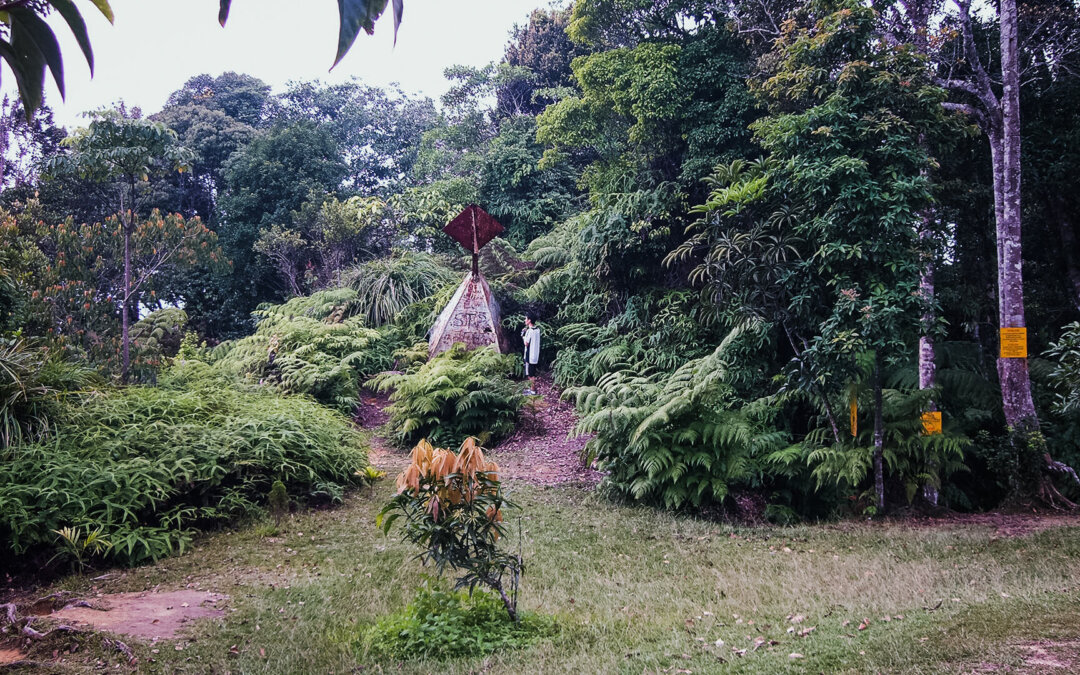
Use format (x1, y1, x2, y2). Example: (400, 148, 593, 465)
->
(48, 110, 192, 382)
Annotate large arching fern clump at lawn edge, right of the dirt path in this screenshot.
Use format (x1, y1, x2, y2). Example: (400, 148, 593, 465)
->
(567, 330, 786, 509)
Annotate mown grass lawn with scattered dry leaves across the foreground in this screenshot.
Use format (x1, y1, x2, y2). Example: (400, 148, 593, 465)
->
(14, 482, 1080, 674)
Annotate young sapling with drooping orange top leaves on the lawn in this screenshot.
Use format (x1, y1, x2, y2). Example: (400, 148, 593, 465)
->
(376, 437, 523, 621)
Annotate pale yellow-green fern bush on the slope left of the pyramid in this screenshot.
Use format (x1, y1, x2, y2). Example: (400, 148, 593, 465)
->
(207, 288, 400, 413)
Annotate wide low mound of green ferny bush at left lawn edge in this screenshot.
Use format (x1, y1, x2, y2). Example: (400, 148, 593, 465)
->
(0, 362, 367, 565)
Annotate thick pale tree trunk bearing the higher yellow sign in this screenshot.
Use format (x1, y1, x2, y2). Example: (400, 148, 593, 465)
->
(990, 0, 1039, 431)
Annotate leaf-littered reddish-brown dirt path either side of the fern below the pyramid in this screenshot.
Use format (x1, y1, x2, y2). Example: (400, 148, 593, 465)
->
(355, 376, 602, 487)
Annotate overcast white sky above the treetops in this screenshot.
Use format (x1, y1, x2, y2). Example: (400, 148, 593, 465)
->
(12, 0, 562, 127)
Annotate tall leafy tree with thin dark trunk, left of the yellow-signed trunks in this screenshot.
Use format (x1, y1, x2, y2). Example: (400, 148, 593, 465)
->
(684, 0, 949, 511)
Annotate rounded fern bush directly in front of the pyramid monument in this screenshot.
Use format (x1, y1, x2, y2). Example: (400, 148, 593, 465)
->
(368, 342, 526, 446)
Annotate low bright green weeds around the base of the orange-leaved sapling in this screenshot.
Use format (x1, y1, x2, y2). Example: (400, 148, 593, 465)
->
(357, 589, 555, 660)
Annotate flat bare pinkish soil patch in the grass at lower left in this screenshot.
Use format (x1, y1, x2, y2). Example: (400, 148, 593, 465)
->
(49, 590, 228, 639)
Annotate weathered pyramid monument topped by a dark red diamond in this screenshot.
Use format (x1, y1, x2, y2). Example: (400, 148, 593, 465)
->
(428, 204, 505, 356)
